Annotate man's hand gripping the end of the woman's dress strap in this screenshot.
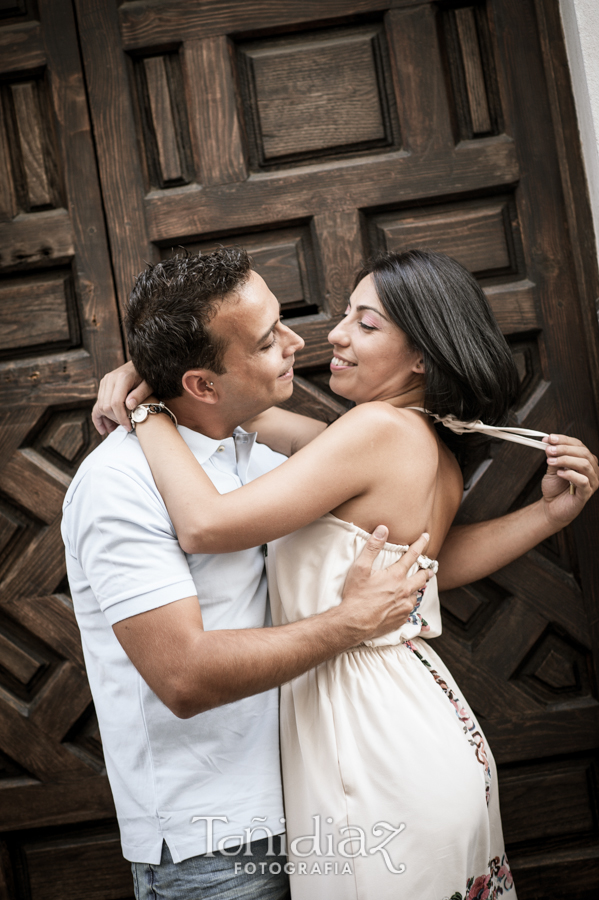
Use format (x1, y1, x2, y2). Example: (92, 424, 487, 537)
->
(541, 434, 599, 531)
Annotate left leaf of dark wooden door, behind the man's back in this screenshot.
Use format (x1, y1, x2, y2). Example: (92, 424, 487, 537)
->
(0, 0, 130, 900)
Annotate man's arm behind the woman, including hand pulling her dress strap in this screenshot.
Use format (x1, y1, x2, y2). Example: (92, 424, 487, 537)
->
(438, 434, 599, 591)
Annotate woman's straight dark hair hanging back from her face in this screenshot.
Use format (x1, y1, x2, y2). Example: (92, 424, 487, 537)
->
(355, 250, 519, 468)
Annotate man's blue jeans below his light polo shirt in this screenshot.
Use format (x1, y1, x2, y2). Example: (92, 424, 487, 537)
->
(131, 836, 290, 900)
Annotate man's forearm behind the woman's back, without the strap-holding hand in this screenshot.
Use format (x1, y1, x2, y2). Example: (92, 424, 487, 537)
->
(437, 500, 559, 591)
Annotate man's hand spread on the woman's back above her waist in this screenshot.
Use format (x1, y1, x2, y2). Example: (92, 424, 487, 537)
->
(337, 525, 432, 643)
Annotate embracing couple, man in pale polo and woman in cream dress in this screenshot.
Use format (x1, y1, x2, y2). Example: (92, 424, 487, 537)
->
(63, 249, 599, 900)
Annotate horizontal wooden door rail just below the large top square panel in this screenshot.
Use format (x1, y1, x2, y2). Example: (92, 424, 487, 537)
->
(146, 137, 520, 241)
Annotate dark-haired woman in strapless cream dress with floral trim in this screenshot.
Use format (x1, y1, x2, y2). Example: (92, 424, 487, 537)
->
(127, 251, 568, 900)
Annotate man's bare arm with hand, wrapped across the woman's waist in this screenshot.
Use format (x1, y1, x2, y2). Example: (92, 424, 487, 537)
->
(113, 526, 430, 718)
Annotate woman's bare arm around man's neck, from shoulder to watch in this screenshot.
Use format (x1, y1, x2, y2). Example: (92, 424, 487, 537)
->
(136, 403, 400, 553)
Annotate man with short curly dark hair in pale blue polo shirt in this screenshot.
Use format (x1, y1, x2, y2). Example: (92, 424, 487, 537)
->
(63, 250, 597, 900)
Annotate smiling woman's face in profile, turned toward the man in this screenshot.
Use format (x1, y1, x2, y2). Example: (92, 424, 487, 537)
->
(328, 275, 424, 405)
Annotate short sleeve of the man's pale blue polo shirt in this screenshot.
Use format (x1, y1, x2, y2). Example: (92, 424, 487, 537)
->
(65, 467, 197, 625)
